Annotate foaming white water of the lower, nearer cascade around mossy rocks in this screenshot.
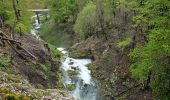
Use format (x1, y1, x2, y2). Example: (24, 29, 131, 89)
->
(58, 48, 99, 100)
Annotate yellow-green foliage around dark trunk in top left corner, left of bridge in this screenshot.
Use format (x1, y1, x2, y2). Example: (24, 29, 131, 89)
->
(0, 0, 31, 32)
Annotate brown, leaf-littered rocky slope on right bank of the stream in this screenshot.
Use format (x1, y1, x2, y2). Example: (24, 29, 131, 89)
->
(70, 9, 152, 100)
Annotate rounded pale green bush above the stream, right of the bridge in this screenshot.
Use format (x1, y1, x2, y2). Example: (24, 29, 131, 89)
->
(74, 2, 97, 40)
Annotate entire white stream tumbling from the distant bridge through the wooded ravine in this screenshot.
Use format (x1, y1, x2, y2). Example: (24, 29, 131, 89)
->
(31, 16, 101, 100)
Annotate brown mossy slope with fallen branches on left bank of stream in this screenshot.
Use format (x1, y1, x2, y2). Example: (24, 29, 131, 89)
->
(0, 29, 73, 100)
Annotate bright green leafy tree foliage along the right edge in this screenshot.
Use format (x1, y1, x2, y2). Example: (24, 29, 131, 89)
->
(130, 0, 170, 100)
